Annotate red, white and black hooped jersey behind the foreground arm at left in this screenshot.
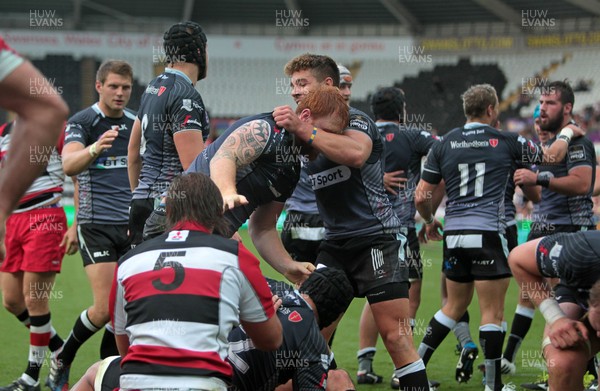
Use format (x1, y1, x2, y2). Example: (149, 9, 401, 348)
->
(0, 122, 65, 213)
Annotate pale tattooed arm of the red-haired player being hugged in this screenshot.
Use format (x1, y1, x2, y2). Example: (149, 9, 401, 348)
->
(210, 120, 271, 209)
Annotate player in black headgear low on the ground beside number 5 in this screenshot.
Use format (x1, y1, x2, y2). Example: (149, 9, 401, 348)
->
(72, 268, 354, 391)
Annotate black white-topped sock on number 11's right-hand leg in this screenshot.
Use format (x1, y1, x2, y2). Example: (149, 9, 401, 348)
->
(479, 324, 504, 390)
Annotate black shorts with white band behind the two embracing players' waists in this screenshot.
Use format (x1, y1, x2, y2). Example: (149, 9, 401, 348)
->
(281, 211, 325, 264)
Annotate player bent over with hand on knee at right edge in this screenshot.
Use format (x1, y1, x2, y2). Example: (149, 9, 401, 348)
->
(508, 231, 600, 390)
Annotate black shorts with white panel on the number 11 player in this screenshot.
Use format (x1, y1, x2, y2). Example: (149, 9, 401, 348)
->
(442, 230, 512, 282)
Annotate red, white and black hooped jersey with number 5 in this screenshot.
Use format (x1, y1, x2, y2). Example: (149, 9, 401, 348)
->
(110, 224, 275, 389)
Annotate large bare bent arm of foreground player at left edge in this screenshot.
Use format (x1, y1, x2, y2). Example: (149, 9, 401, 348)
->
(0, 37, 69, 262)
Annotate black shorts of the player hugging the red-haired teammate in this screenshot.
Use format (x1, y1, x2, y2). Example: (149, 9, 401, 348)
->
(317, 234, 408, 297)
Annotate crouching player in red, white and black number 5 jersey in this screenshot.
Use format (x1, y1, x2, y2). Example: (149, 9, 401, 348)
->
(110, 173, 283, 391)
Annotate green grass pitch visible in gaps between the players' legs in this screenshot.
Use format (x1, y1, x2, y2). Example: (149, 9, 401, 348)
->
(0, 232, 543, 391)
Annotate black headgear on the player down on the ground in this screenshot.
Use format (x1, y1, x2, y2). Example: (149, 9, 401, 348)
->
(300, 267, 354, 329)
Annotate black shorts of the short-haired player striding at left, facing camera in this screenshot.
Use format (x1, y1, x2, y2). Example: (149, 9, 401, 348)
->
(77, 223, 131, 266)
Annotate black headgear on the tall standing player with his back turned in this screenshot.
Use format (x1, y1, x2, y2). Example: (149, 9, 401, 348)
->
(163, 21, 206, 80)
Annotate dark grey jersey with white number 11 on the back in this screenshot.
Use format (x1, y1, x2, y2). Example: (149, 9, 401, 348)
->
(422, 123, 543, 232)
